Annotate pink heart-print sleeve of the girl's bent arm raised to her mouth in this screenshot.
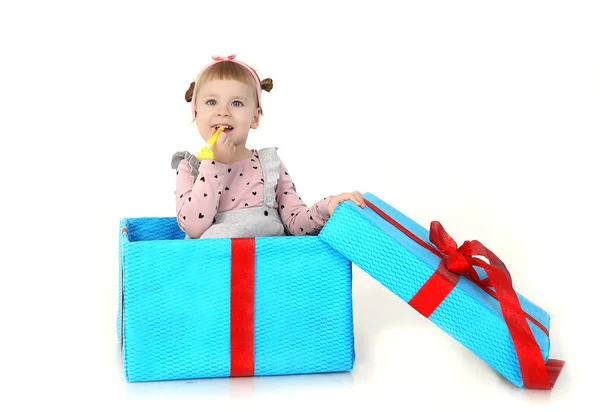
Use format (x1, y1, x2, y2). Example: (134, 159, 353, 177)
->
(175, 159, 227, 239)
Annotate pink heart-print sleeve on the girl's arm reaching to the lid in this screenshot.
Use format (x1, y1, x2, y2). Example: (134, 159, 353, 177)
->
(275, 163, 332, 236)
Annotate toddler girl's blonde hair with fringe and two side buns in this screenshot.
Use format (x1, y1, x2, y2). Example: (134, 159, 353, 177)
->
(185, 61, 273, 120)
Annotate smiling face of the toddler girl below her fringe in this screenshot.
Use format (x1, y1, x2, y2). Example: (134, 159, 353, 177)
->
(196, 80, 260, 145)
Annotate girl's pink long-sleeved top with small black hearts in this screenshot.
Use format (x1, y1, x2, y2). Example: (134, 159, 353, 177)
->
(175, 150, 331, 239)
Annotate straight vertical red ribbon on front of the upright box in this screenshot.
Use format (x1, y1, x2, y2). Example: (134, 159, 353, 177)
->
(230, 238, 256, 376)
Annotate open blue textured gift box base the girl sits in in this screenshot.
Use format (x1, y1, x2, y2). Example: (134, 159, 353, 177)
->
(116, 217, 354, 382)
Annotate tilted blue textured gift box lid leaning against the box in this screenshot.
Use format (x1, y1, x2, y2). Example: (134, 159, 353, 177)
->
(319, 193, 562, 387)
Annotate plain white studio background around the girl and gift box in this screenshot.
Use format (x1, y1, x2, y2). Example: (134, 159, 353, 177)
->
(0, 0, 600, 410)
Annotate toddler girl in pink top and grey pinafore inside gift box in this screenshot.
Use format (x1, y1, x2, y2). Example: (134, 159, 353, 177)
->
(171, 55, 365, 239)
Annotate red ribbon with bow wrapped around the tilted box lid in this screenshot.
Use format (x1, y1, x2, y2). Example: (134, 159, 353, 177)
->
(365, 199, 564, 389)
